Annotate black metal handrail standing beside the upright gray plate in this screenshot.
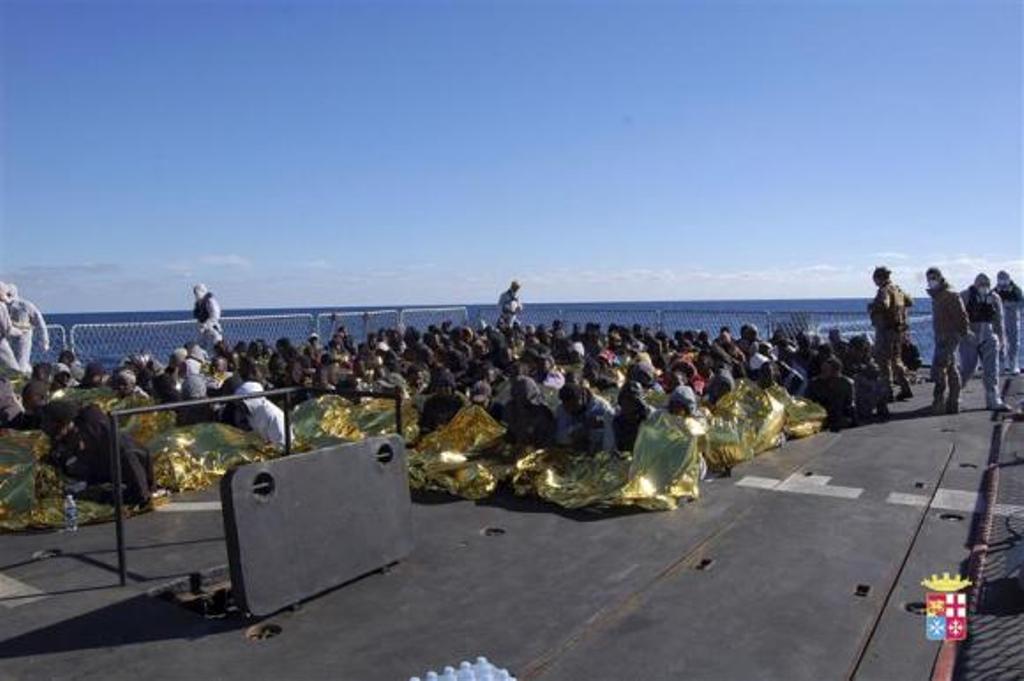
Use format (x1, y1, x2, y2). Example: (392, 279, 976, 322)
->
(110, 387, 402, 587)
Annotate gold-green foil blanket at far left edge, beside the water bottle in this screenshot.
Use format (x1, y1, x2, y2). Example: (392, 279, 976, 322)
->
(0, 430, 114, 531)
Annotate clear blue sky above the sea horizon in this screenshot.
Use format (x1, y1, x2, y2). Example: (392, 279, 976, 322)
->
(0, 0, 1024, 311)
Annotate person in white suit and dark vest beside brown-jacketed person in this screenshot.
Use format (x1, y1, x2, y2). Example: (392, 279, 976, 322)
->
(959, 273, 1008, 412)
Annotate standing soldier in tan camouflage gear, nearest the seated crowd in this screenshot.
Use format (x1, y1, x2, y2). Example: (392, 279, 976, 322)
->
(867, 267, 913, 400)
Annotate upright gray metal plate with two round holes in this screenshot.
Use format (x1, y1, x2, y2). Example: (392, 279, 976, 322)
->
(220, 436, 413, 615)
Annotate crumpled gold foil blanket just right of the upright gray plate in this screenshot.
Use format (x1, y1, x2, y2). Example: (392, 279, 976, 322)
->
(409, 405, 512, 500)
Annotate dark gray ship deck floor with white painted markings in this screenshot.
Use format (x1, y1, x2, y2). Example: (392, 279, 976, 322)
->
(0, 381, 1024, 681)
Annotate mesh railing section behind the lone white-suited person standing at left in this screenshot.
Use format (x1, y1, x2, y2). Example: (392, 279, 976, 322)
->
(71, 314, 316, 365)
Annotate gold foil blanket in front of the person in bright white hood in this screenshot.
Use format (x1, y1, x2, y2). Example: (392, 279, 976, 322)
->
(146, 423, 281, 492)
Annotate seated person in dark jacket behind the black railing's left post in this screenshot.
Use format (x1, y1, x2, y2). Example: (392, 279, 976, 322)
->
(43, 400, 154, 506)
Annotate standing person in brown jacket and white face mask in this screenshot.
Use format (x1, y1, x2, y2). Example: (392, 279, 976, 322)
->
(925, 267, 969, 415)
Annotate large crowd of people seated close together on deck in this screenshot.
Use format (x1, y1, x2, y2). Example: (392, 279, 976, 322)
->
(0, 322, 913, 500)
